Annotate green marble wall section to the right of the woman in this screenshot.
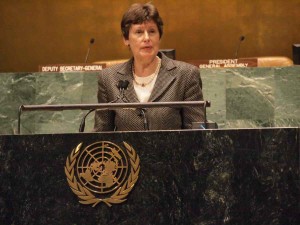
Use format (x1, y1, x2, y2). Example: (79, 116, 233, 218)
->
(201, 66, 300, 128)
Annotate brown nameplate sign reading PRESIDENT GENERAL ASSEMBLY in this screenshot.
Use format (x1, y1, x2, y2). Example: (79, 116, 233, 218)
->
(188, 58, 257, 69)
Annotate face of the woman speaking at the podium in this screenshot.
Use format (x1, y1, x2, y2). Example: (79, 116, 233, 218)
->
(124, 20, 160, 60)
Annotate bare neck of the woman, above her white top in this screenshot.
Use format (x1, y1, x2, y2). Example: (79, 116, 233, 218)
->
(133, 56, 159, 77)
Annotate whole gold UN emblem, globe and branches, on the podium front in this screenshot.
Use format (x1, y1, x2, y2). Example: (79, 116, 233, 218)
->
(65, 141, 140, 207)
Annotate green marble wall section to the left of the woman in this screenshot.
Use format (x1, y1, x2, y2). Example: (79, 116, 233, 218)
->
(0, 73, 97, 134)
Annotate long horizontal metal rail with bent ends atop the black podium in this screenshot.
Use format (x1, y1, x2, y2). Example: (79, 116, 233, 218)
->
(18, 101, 210, 134)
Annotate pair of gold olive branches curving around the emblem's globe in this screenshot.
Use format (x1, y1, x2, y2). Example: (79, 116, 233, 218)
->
(64, 142, 140, 207)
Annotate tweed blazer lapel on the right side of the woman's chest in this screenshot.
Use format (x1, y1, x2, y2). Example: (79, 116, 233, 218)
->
(149, 54, 176, 102)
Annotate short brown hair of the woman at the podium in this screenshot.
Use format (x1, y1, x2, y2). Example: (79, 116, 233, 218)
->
(121, 3, 164, 40)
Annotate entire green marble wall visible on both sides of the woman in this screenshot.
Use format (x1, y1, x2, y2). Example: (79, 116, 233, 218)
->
(0, 67, 300, 134)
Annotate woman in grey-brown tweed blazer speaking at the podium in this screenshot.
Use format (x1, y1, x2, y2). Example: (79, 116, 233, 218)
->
(94, 3, 204, 132)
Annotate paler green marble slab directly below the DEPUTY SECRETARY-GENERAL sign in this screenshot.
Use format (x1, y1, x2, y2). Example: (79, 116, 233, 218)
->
(28, 73, 97, 133)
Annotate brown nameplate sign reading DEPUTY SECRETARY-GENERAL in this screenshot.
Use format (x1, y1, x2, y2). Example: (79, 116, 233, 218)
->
(39, 63, 106, 73)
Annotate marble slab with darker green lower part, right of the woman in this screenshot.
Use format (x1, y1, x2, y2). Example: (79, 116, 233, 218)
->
(225, 68, 274, 127)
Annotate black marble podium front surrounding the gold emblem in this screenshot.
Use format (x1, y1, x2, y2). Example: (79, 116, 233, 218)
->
(0, 128, 300, 225)
